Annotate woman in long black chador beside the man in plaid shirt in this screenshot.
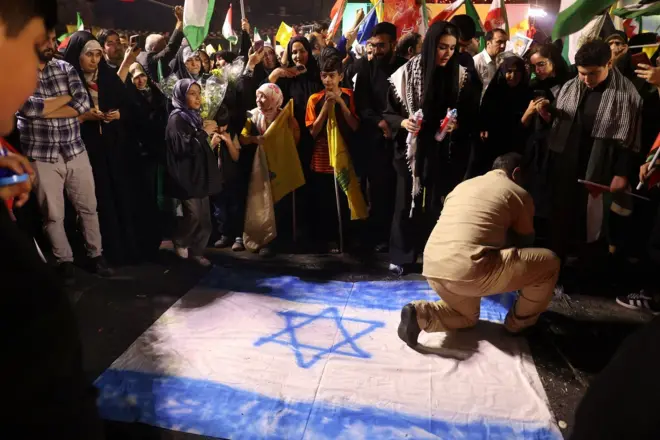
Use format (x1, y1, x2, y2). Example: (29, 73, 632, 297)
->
(64, 31, 140, 265)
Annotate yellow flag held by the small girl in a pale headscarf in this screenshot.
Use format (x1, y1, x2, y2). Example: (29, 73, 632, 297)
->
(263, 100, 305, 203)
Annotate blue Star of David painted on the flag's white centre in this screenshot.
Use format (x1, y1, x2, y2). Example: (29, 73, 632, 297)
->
(254, 307, 385, 368)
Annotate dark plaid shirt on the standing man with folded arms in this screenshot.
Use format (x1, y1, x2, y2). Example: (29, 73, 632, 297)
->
(16, 60, 91, 163)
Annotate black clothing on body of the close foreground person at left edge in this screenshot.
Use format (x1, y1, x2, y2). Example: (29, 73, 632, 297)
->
(0, 203, 104, 440)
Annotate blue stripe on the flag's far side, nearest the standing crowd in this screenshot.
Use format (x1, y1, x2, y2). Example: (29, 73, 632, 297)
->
(201, 268, 515, 322)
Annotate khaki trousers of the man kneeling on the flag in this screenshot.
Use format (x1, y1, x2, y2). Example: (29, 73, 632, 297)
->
(413, 248, 560, 332)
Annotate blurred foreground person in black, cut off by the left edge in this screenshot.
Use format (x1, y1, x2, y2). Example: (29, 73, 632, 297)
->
(0, 0, 103, 440)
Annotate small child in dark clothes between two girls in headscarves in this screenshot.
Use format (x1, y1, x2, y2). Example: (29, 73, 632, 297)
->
(213, 105, 250, 252)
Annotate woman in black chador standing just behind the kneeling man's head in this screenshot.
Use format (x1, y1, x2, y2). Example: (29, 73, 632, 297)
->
(479, 56, 532, 165)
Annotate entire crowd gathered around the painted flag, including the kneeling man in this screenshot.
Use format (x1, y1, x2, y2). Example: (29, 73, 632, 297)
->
(0, 0, 660, 439)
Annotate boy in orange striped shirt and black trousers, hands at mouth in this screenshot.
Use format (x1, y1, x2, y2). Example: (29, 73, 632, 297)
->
(305, 50, 366, 252)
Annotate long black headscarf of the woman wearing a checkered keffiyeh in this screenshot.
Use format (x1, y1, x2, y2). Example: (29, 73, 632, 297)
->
(421, 21, 459, 125)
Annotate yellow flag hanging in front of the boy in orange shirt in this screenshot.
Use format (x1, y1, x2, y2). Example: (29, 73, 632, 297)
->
(327, 106, 369, 220)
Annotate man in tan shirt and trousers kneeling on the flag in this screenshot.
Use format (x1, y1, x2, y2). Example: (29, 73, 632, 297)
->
(399, 153, 560, 347)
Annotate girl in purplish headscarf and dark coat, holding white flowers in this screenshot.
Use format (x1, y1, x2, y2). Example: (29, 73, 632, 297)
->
(165, 79, 224, 267)
